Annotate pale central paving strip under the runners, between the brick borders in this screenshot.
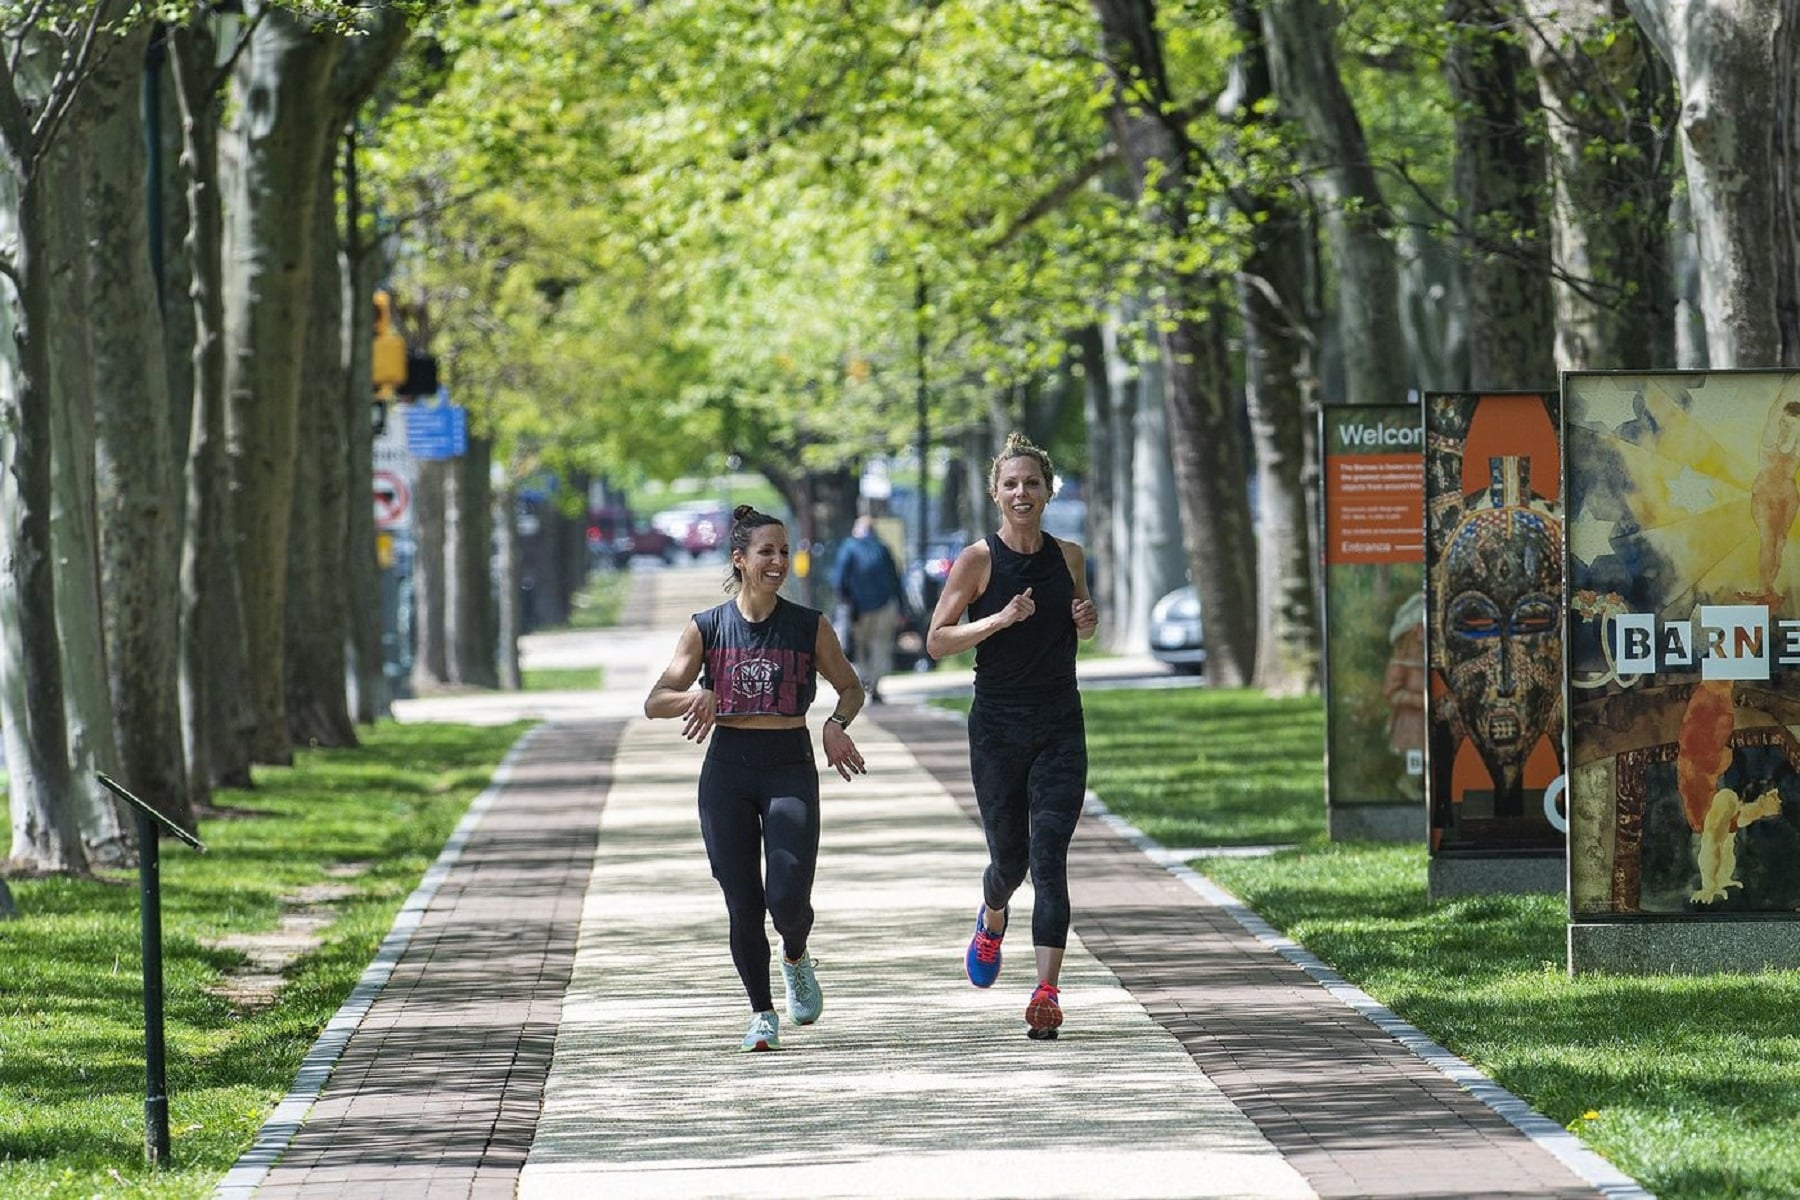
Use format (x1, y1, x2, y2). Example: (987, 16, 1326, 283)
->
(518, 721, 1312, 1200)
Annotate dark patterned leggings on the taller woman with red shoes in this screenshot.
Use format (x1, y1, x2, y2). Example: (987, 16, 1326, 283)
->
(968, 694, 1087, 950)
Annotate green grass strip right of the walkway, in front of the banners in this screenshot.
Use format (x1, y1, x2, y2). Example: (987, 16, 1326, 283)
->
(1058, 689, 1800, 1200)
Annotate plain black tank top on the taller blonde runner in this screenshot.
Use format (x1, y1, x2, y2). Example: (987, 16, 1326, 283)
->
(968, 533, 1075, 703)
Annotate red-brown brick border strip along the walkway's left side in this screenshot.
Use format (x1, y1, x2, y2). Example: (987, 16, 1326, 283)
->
(227, 721, 625, 1200)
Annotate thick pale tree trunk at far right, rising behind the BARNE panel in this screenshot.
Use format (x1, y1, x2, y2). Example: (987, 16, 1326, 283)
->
(1625, 0, 1800, 369)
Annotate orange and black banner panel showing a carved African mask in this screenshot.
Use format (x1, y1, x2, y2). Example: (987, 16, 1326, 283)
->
(1424, 392, 1562, 855)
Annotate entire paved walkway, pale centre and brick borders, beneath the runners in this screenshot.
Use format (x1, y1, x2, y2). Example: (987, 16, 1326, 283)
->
(218, 568, 1645, 1200)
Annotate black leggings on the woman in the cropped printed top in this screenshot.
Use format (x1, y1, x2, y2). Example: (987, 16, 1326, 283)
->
(700, 725, 819, 1013)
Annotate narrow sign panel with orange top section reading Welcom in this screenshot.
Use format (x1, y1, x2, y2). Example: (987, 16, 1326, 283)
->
(1319, 405, 1426, 805)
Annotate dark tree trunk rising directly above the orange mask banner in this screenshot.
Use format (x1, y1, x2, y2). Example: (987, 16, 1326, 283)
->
(1444, 0, 1557, 390)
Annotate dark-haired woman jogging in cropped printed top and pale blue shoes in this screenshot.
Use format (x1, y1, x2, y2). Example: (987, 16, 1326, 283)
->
(644, 504, 864, 1051)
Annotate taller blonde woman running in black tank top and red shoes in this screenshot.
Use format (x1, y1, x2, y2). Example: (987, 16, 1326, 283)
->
(925, 434, 1100, 1040)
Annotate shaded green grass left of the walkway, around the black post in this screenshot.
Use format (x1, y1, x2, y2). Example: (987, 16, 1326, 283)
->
(0, 723, 524, 1200)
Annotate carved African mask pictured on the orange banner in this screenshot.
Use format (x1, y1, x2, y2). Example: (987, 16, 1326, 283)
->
(1438, 457, 1562, 817)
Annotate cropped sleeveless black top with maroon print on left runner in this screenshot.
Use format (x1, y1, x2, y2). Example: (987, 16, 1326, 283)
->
(693, 596, 819, 716)
